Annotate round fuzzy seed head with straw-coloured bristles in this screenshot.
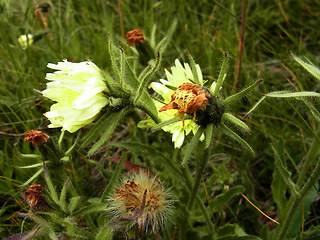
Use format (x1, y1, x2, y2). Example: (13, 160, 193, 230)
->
(110, 173, 172, 232)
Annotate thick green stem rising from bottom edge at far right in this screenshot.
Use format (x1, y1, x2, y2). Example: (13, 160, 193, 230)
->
(275, 157, 320, 240)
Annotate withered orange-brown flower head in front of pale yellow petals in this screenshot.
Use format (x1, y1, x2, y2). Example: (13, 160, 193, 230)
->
(159, 83, 211, 118)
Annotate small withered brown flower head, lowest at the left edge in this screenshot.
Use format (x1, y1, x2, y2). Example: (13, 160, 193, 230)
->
(24, 184, 48, 212)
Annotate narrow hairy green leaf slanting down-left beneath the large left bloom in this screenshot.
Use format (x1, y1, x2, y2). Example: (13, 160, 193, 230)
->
(88, 108, 127, 155)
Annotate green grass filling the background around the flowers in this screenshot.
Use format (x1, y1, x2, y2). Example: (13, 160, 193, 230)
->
(0, 0, 320, 239)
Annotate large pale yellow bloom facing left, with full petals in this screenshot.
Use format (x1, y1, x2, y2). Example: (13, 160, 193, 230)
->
(42, 60, 108, 133)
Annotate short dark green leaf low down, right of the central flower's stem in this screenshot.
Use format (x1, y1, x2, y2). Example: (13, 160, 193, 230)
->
(208, 186, 244, 213)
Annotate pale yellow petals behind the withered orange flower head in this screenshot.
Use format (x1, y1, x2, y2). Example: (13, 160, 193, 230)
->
(149, 59, 209, 148)
